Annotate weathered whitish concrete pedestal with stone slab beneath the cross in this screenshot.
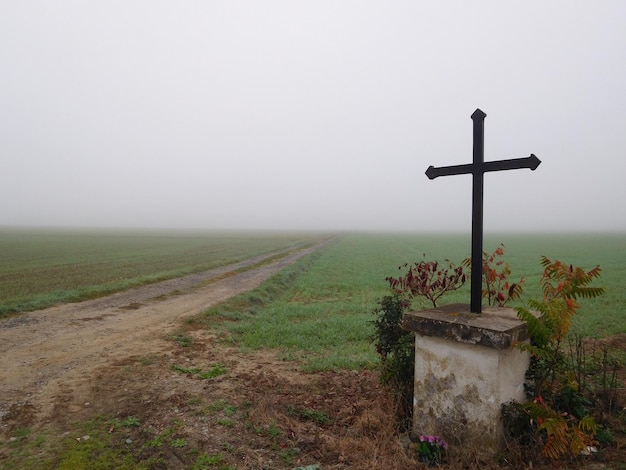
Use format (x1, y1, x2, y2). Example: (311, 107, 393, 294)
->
(403, 304, 530, 454)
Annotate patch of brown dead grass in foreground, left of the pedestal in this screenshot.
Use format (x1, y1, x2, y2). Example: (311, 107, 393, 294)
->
(25, 324, 624, 470)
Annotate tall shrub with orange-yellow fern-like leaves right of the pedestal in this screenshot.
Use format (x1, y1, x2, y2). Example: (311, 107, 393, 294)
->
(503, 257, 604, 459)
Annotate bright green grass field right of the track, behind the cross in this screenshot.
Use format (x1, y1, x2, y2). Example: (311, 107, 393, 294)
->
(201, 229, 626, 371)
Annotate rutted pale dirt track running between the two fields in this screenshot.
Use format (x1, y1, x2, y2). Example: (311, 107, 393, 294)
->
(0, 245, 330, 436)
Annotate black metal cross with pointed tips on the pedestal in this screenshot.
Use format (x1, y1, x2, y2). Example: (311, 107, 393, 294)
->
(426, 109, 541, 313)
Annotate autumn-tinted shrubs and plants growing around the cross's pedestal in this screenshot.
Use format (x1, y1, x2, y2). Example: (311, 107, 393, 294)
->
(374, 241, 626, 468)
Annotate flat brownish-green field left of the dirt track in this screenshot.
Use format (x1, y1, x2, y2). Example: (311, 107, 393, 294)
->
(0, 229, 322, 316)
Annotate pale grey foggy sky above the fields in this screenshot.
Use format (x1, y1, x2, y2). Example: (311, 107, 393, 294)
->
(0, 0, 626, 233)
